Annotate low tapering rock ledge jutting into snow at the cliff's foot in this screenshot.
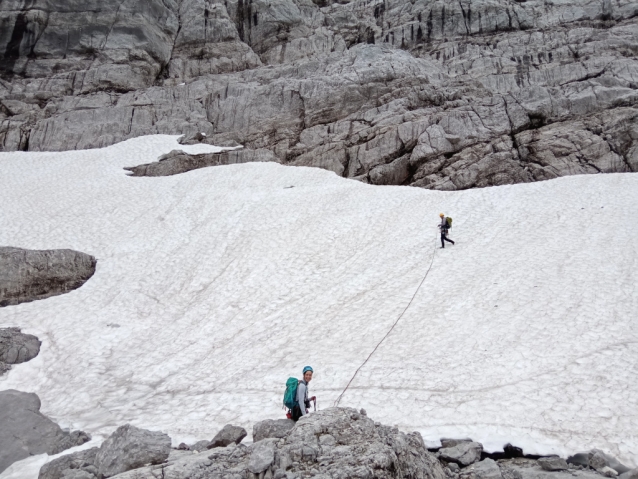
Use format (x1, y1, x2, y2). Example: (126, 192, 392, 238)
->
(126, 149, 278, 176)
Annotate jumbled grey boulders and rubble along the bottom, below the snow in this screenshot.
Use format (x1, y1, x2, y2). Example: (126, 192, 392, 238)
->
(31, 408, 638, 479)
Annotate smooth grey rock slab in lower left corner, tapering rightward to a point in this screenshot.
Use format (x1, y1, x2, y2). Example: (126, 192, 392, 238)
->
(0, 389, 90, 472)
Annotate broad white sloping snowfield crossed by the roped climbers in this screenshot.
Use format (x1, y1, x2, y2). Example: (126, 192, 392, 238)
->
(0, 136, 638, 477)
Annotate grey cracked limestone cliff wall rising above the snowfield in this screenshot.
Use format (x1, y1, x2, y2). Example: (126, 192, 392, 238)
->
(0, 0, 638, 190)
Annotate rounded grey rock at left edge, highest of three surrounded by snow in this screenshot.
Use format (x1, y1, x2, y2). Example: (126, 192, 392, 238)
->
(0, 247, 97, 307)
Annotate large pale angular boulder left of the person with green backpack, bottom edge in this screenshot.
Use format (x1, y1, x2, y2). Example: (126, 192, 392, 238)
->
(95, 424, 171, 477)
